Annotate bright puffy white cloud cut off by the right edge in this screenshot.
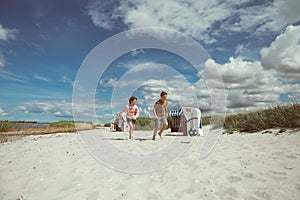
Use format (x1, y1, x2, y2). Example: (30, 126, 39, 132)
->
(260, 25, 300, 81)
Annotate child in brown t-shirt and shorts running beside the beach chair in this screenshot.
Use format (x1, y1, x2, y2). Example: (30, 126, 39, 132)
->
(152, 92, 168, 140)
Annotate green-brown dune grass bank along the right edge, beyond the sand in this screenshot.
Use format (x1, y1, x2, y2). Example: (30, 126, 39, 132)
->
(224, 103, 300, 133)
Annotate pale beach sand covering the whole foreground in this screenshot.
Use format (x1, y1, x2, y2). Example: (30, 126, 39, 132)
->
(0, 127, 300, 200)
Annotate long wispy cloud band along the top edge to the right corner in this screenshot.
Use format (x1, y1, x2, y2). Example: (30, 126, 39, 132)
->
(87, 0, 300, 44)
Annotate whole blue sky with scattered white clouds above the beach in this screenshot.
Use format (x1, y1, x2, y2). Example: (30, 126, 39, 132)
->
(0, 0, 300, 122)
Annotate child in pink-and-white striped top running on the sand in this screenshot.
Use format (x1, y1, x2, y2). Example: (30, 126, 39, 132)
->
(117, 96, 140, 140)
